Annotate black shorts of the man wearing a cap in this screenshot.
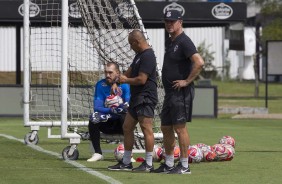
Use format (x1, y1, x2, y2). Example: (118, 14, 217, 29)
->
(161, 86, 194, 125)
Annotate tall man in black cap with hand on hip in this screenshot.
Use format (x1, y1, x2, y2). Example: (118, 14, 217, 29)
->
(153, 10, 204, 174)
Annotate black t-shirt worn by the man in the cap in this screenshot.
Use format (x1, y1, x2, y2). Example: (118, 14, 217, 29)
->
(162, 32, 197, 93)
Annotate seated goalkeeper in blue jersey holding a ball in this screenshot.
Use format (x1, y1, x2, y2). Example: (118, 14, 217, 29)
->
(87, 62, 130, 162)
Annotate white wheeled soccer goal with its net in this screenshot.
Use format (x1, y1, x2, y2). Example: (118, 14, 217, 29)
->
(23, 0, 163, 160)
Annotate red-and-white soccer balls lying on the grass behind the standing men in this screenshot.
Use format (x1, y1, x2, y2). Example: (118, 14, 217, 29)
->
(114, 136, 235, 163)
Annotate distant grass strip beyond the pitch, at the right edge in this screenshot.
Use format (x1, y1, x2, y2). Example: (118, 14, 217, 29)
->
(212, 80, 282, 113)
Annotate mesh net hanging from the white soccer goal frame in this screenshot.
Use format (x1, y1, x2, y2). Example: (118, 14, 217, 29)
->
(24, 0, 163, 141)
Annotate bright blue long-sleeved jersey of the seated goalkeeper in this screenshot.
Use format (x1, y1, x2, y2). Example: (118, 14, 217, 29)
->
(93, 79, 130, 114)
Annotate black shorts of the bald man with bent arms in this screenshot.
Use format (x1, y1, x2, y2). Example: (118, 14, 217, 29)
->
(128, 103, 155, 120)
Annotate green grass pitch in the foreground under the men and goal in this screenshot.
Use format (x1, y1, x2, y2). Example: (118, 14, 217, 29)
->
(0, 117, 282, 184)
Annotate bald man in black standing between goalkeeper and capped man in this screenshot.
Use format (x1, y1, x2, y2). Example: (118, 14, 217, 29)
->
(108, 30, 158, 172)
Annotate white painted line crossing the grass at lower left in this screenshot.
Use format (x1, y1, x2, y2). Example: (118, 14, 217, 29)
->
(0, 134, 121, 184)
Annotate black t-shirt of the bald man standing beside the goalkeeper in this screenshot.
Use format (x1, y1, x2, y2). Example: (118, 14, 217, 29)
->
(130, 49, 158, 107)
